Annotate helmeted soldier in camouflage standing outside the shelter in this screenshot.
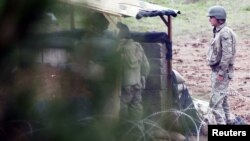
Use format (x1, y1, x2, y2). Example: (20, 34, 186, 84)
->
(207, 6, 236, 124)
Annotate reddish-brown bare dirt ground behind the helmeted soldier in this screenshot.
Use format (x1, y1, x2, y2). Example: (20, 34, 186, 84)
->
(173, 34, 250, 123)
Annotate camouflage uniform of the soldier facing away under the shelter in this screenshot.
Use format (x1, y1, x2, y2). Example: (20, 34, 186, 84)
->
(119, 39, 149, 120)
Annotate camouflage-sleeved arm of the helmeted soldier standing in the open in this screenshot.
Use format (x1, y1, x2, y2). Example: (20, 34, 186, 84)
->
(219, 31, 233, 76)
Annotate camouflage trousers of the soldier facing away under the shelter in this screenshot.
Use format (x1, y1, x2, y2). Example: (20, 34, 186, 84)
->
(120, 85, 143, 121)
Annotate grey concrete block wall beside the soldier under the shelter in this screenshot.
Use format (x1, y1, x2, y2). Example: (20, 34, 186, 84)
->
(141, 43, 167, 117)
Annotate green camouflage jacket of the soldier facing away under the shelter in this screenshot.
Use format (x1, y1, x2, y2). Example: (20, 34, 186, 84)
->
(118, 39, 150, 87)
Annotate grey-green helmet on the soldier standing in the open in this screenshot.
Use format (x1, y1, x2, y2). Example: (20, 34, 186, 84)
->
(208, 6, 227, 20)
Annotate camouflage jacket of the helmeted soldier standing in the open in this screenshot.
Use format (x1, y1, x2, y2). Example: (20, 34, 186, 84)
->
(207, 24, 236, 76)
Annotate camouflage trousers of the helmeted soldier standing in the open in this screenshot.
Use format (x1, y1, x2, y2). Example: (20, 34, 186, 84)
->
(209, 72, 230, 124)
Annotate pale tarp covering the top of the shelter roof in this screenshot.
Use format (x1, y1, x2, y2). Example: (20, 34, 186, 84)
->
(59, 0, 180, 17)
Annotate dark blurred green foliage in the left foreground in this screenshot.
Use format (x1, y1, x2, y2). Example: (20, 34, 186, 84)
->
(0, 0, 126, 141)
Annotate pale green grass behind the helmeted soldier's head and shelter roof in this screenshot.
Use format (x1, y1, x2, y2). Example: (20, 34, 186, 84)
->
(119, 0, 250, 41)
